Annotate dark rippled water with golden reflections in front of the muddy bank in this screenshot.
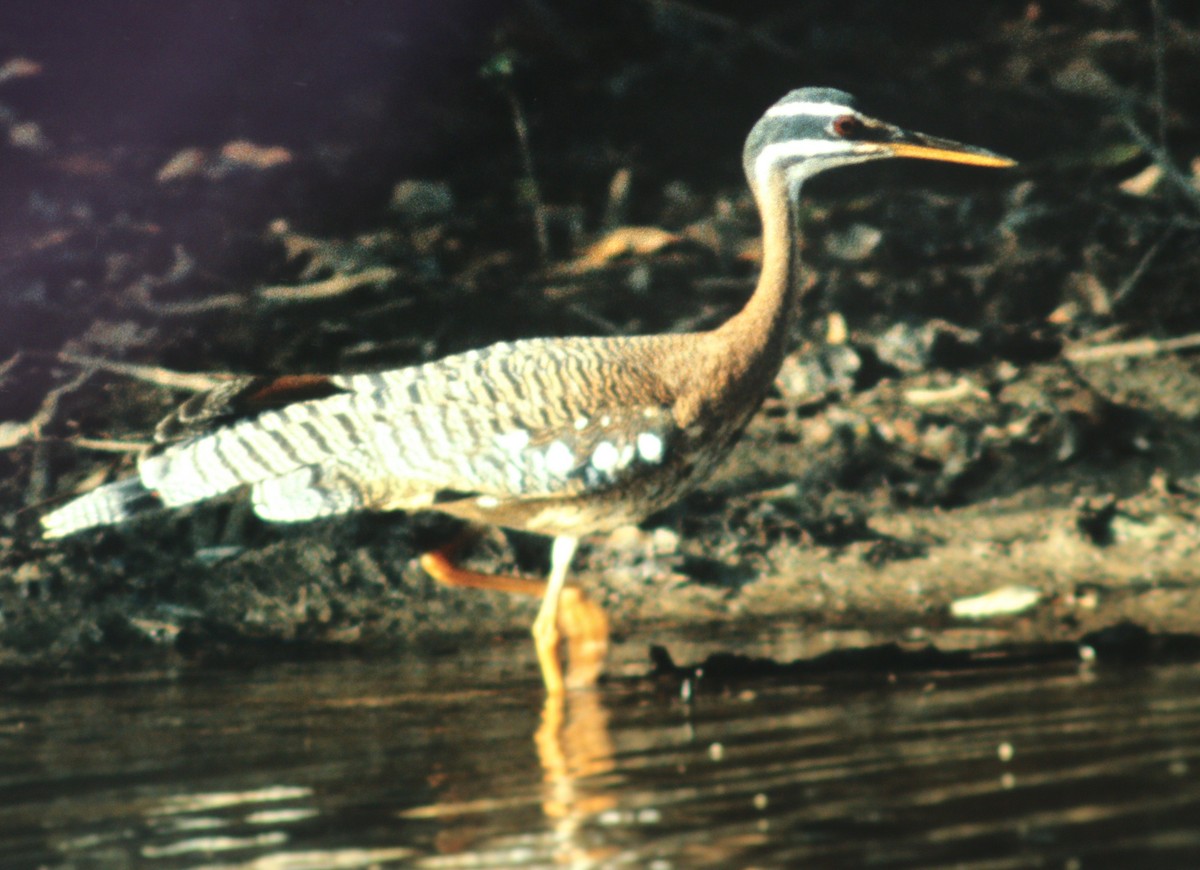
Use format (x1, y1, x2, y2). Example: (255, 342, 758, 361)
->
(0, 638, 1200, 869)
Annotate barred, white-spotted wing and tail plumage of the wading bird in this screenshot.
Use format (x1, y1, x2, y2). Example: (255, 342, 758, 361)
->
(43, 338, 678, 535)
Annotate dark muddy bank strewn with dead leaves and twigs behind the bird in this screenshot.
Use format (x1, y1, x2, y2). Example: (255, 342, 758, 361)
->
(0, 0, 1200, 671)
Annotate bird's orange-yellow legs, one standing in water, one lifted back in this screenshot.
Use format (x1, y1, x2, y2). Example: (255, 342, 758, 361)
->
(421, 538, 608, 695)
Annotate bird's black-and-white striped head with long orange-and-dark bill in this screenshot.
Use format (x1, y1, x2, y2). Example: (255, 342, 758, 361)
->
(743, 88, 1015, 196)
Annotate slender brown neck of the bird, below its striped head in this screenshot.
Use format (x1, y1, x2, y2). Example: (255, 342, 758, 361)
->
(713, 175, 799, 383)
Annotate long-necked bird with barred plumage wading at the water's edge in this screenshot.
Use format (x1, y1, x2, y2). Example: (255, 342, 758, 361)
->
(42, 88, 1015, 696)
